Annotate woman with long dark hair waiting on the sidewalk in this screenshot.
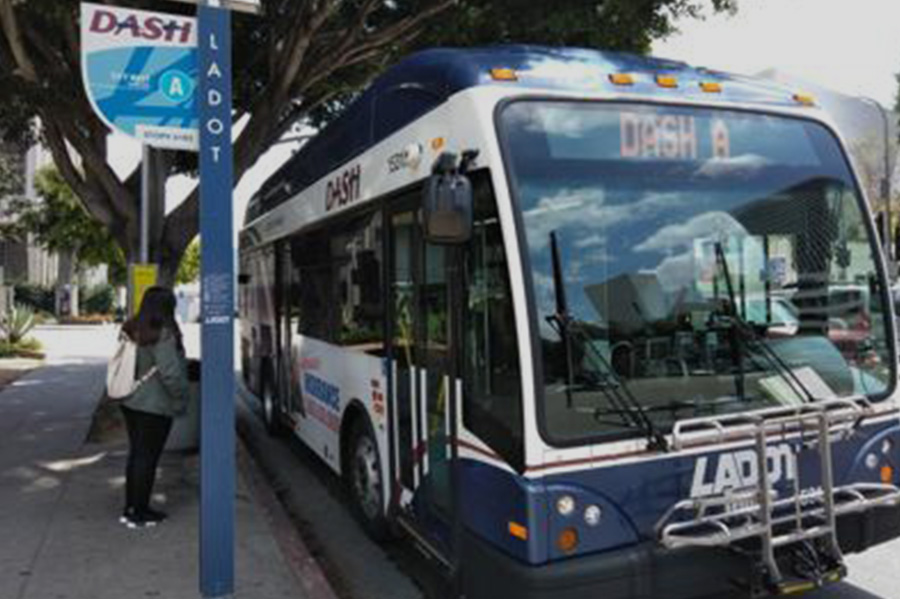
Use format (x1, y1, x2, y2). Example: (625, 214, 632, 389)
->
(120, 287, 190, 528)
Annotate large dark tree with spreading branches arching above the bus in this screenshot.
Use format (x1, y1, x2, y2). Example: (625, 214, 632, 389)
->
(0, 0, 736, 282)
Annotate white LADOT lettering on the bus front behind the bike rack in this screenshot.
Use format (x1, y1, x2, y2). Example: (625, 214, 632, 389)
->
(691, 445, 797, 497)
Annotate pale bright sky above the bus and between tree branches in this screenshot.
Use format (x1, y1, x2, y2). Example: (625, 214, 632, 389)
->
(110, 0, 900, 230)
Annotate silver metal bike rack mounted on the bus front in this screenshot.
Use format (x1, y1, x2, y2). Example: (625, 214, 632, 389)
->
(656, 397, 900, 585)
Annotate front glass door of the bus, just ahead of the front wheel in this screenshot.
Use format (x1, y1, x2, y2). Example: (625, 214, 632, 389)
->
(387, 197, 453, 552)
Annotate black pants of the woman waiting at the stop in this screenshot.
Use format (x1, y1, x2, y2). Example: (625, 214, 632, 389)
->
(122, 406, 172, 512)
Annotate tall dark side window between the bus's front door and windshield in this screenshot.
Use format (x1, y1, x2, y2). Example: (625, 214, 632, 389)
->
(463, 170, 524, 468)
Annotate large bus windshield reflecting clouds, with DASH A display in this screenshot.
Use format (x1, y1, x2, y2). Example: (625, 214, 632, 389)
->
(498, 100, 895, 443)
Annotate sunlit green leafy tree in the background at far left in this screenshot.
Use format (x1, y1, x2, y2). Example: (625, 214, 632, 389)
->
(0, 167, 125, 286)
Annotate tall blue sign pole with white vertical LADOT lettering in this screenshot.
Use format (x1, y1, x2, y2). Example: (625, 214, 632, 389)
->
(197, 5, 235, 598)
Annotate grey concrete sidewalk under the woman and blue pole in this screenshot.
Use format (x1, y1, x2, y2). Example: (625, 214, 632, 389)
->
(0, 330, 307, 599)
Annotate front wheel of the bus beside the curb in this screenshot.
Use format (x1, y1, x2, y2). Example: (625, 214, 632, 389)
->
(343, 416, 388, 541)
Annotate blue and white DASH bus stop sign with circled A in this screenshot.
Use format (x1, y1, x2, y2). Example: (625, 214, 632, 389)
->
(81, 3, 199, 150)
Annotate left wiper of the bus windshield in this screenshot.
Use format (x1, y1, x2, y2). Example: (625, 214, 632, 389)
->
(547, 231, 669, 451)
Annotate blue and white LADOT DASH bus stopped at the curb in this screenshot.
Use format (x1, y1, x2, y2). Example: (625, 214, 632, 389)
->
(239, 46, 900, 599)
